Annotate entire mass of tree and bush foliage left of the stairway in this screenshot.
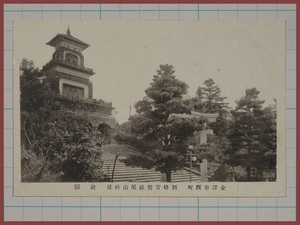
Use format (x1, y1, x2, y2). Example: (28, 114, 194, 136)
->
(20, 59, 102, 182)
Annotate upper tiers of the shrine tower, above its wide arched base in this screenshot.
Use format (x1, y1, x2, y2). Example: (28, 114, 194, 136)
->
(43, 27, 94, 99)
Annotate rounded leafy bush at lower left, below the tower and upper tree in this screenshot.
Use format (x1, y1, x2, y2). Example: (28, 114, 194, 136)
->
(21, 110, 103, 182)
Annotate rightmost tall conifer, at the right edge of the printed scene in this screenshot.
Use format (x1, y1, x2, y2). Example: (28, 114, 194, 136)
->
(227, 88, 276, 181)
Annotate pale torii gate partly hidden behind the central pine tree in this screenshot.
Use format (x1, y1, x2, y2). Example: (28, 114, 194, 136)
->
(169, 111, 219, 182)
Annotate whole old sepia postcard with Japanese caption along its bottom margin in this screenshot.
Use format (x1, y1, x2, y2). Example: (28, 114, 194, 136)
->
(14, 20, 286, 197)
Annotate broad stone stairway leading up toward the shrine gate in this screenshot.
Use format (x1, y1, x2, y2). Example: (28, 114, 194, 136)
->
(102, 145, 201, 182)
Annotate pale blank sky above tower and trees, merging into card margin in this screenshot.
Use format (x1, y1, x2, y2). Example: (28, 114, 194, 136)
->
(14, 21, 285, 124)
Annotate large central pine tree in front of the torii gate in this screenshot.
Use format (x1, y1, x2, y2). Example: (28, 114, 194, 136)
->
(121, 64, 203, 182)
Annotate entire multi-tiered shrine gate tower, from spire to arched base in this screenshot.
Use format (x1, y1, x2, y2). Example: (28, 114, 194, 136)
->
(42, 27, 116, 142)
